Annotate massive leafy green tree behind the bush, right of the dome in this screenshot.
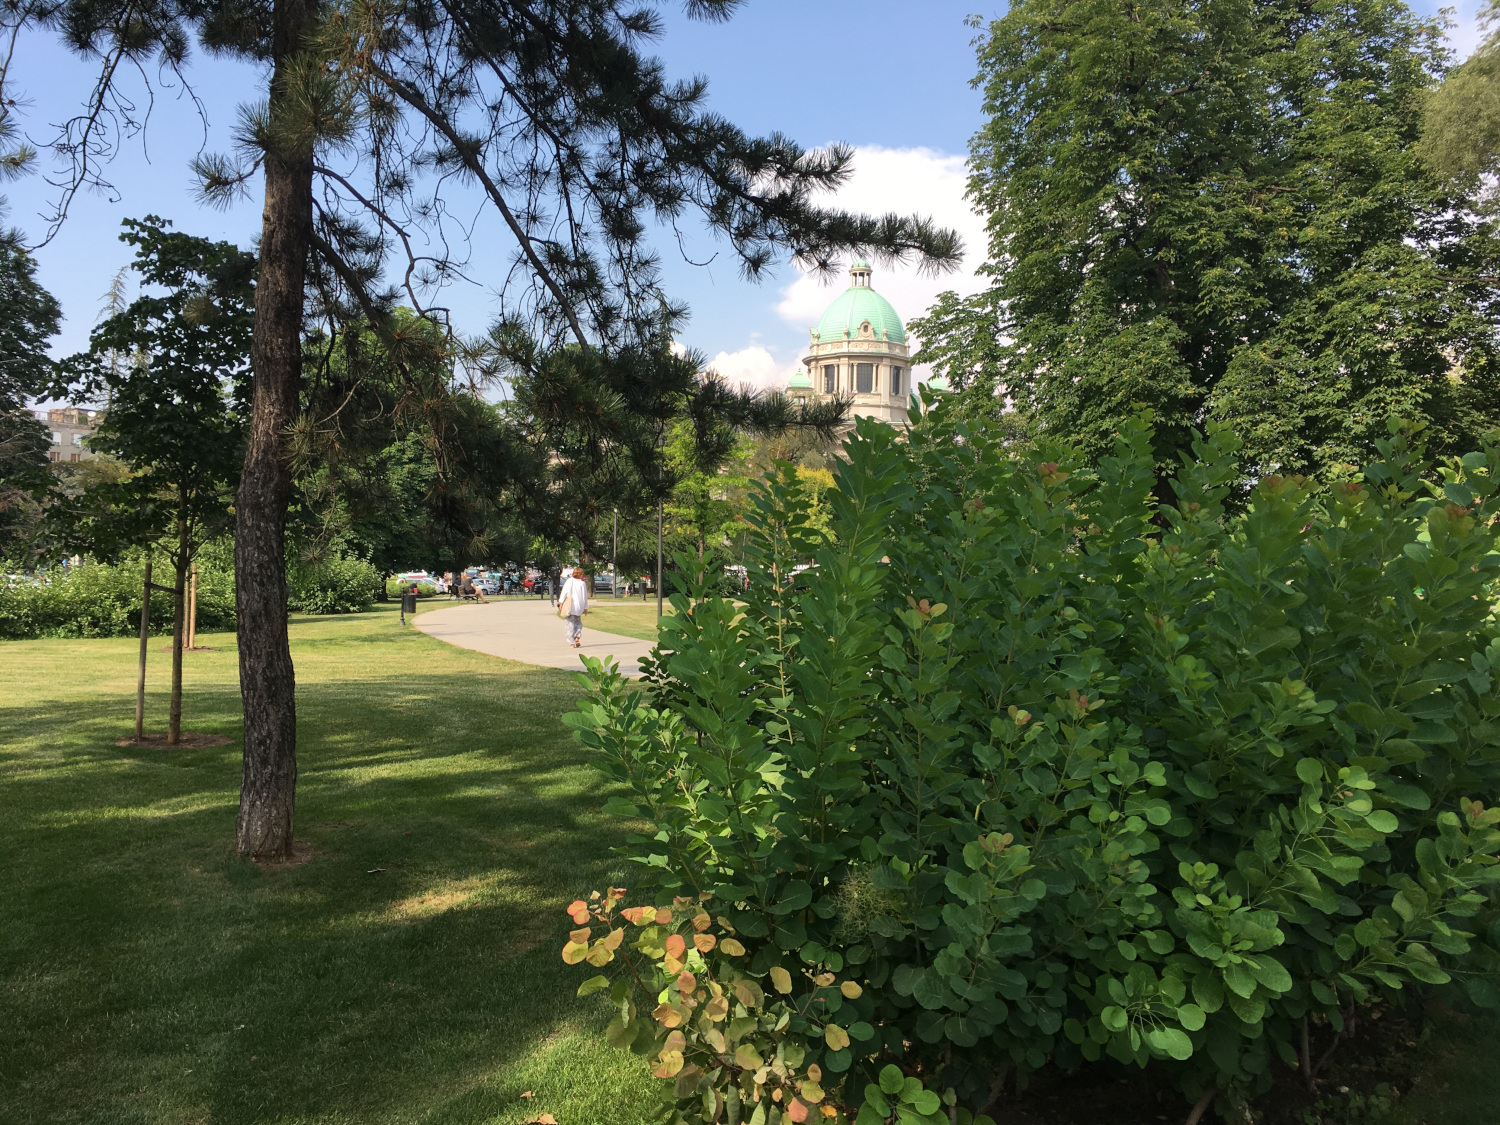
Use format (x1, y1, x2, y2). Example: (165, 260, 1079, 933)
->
(921, 0, 1500, 473)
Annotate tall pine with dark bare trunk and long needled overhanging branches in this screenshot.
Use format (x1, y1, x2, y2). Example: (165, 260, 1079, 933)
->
(14, 0, 960, 860)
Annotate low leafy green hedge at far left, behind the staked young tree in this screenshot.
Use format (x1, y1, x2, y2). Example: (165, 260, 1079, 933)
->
(0, 549, 234, 641)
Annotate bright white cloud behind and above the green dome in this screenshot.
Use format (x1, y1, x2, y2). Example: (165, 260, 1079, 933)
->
(776, 146, 989, 380)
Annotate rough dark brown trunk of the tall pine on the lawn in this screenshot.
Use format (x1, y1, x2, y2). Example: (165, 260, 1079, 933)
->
(234, 0, 317, 861)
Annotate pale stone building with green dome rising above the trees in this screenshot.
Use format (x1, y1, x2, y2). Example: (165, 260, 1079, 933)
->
(786, 258, 912, 426)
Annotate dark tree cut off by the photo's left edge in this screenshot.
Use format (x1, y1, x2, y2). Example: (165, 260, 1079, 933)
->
(0, 234, 62, 558)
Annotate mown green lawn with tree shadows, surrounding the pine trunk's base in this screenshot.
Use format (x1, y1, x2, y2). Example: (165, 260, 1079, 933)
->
(0, 608, 656, 1125)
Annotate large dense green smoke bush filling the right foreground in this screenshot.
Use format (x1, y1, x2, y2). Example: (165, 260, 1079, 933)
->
(570, 408, 1500, 1125)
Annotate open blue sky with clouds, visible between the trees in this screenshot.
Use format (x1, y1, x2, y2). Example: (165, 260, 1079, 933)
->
(3, 0, 1476, 396)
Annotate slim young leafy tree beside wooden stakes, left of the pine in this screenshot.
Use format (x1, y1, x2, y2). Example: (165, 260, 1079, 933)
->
(59, 216, 253, 746)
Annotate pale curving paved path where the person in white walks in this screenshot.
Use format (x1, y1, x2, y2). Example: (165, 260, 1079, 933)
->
(416, 597, 651, 677)
